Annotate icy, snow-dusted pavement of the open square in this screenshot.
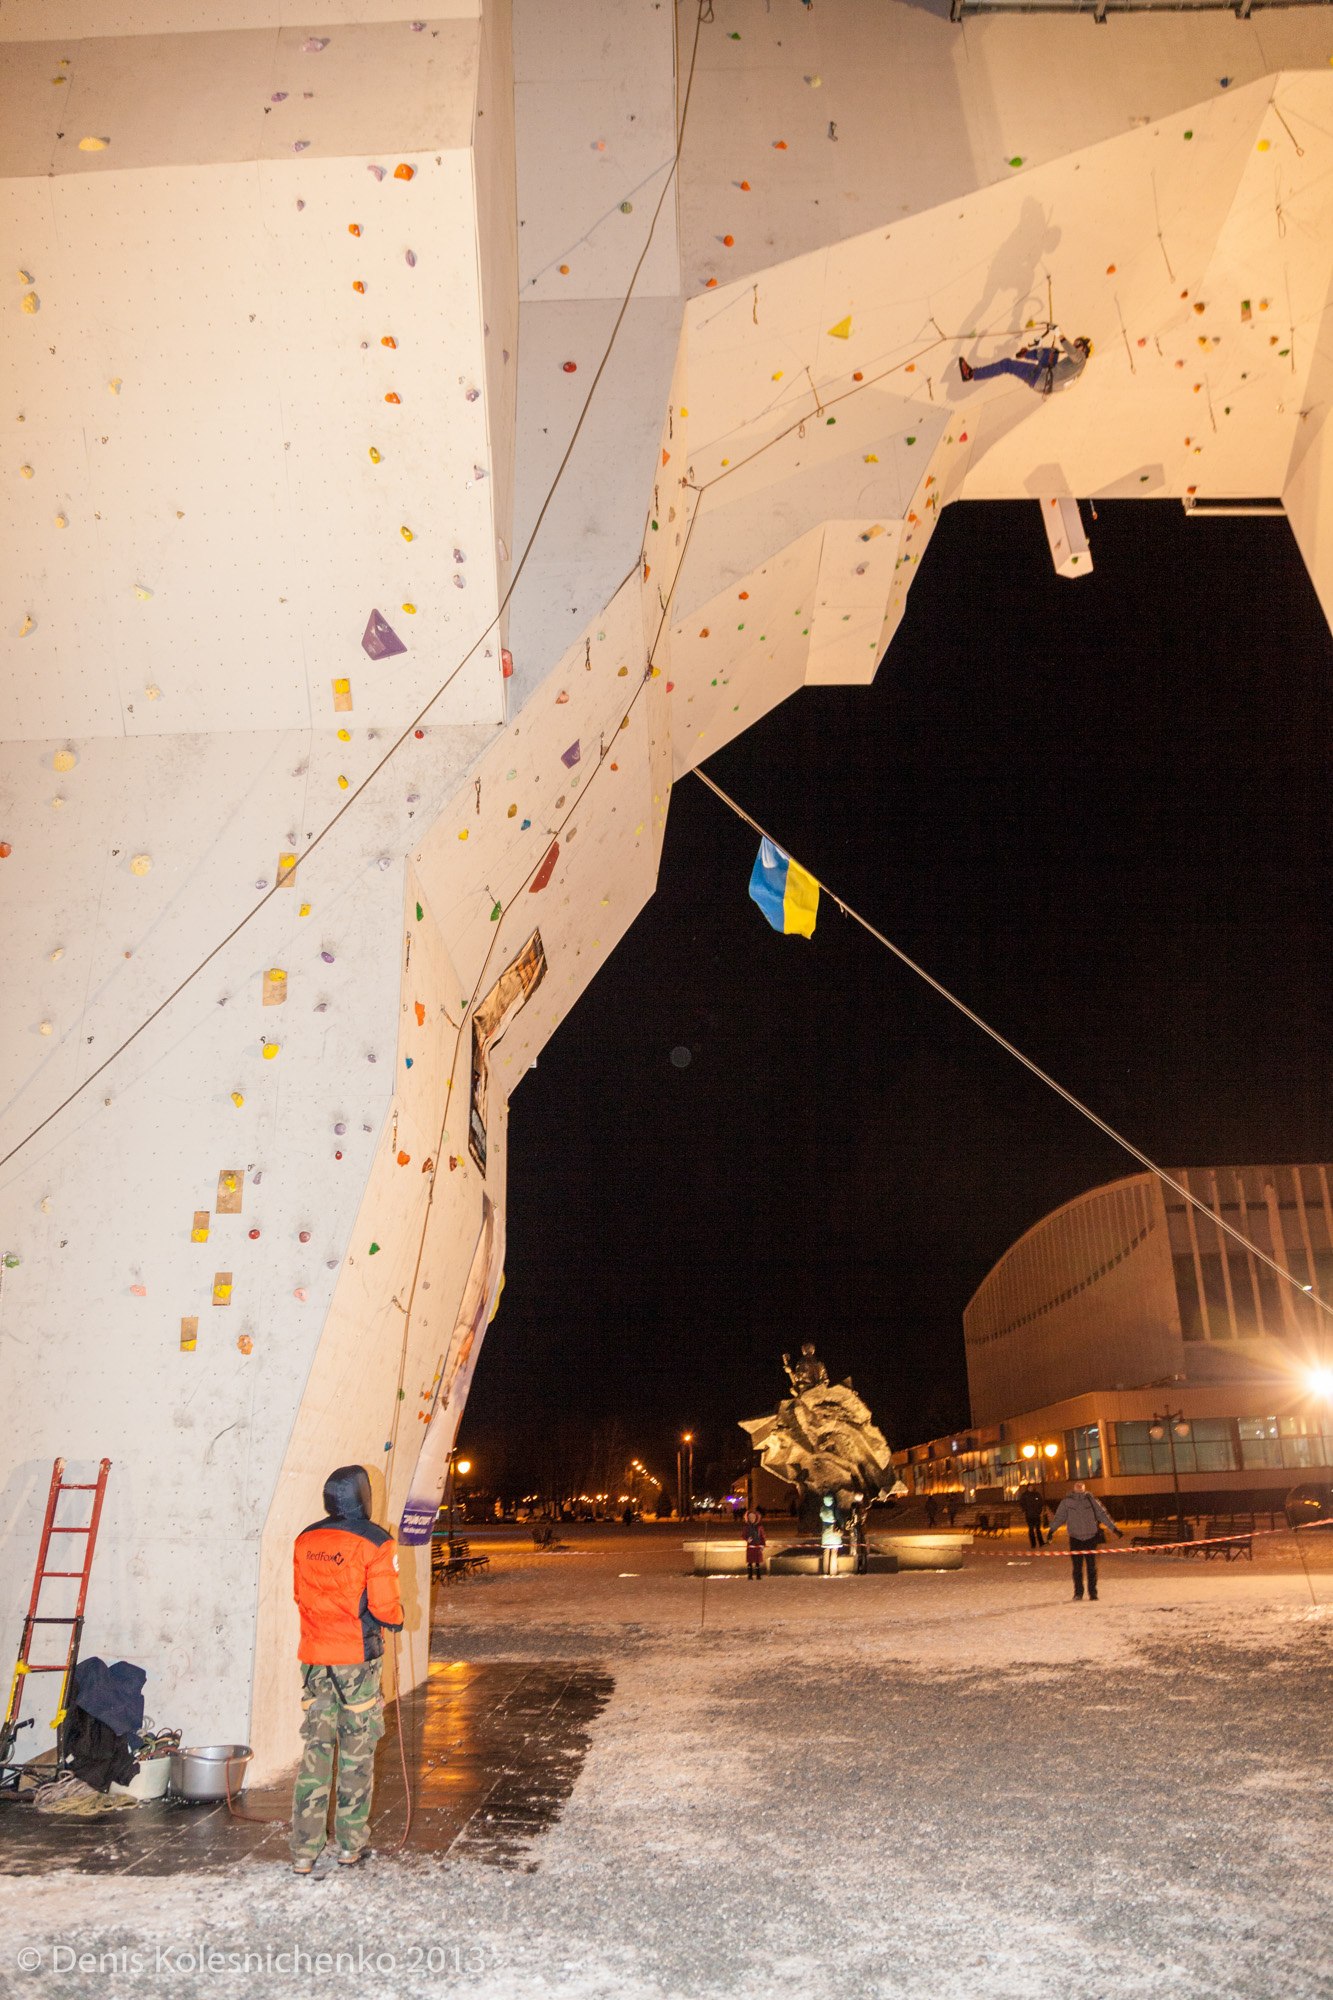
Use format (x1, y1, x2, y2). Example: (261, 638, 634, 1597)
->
(0, 1528, 1333, 2000)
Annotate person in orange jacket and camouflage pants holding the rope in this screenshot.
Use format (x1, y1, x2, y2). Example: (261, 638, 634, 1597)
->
(292, 1466, 402, 1874)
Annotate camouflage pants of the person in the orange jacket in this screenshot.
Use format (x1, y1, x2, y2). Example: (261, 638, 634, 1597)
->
(292, 1660, 384, 1860)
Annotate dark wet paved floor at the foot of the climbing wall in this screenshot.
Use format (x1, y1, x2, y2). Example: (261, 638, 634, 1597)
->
(0, 1660, 612, 1876)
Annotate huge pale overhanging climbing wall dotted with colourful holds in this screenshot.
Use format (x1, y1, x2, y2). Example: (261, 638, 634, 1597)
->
(0, 0, 1333, 1774)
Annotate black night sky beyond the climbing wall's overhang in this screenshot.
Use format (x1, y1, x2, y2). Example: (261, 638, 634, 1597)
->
(462, 502, 1333, 1490)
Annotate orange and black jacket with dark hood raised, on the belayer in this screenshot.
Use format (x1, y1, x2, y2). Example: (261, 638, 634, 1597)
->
(292, 1466, 402, 1666)
